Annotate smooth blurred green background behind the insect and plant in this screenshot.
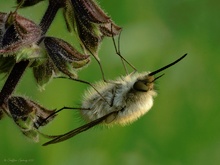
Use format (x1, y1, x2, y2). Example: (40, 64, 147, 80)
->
(0, 0, 220, 165)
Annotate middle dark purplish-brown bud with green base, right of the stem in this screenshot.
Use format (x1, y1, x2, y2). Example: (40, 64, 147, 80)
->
(33, 37, 90, 87)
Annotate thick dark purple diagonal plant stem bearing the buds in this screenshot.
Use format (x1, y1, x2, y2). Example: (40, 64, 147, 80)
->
(0, 1, 61, 107)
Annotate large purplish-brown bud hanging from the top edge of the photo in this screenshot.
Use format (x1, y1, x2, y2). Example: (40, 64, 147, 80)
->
(64, 0, 121, 57)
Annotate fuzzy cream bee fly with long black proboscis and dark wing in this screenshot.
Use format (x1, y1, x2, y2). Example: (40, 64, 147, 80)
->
(43, 54, 186, 146)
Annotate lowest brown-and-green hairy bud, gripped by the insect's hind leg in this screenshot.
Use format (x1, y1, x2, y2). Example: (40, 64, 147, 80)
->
(5, 96, 56, 142)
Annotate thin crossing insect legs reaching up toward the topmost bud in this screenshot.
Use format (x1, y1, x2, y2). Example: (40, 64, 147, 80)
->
(111, 24, 137, 74)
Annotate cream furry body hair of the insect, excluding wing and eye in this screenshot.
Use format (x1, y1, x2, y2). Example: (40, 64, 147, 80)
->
(81, 72, 157, 125)
